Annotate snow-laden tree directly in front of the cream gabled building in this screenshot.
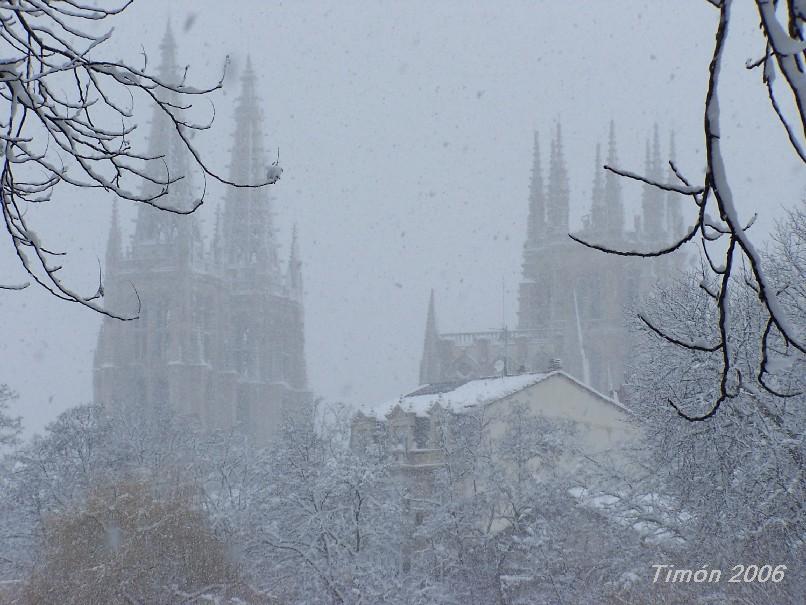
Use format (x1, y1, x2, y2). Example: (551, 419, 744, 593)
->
(409, 402, 651, 604)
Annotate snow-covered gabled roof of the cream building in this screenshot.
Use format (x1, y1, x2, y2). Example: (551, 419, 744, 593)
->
(359, 370, 629, 419)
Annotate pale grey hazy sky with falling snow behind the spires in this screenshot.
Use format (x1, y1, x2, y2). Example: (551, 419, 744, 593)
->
(0, 0, 804, 430)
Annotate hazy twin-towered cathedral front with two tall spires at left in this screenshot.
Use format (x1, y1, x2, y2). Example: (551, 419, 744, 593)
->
(94, 31, 311, 443)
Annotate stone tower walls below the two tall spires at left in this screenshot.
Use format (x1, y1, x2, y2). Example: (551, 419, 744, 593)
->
(94, 255, 311, 442)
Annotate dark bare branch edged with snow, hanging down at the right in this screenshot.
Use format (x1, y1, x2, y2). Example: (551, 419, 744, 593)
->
(570, 0, 806, 422)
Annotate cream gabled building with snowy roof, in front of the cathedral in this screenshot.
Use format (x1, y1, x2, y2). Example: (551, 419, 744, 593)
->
(351, 370, 638, 588)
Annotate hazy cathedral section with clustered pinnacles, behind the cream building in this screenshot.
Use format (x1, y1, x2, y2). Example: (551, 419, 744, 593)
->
(420, 124, 684, 396)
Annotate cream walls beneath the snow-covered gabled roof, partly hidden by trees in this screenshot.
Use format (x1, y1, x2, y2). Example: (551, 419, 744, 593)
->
(351, 373, 638, 552)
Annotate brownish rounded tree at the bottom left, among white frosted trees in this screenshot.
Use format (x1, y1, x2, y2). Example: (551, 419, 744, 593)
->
(23, 481, 268, 605)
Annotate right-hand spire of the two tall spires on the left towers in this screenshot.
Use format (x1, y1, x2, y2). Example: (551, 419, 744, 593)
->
(222, 59, 280, 280)
